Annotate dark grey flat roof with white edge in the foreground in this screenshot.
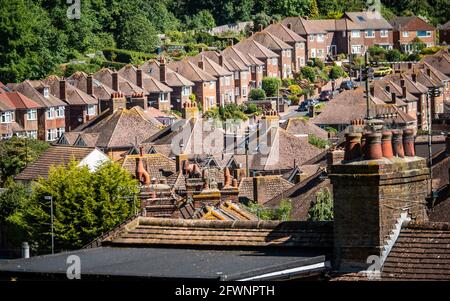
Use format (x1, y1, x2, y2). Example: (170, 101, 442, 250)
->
(0, 247, 328, 280)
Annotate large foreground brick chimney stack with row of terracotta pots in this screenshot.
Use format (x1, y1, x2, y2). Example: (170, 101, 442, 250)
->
(329, 120, 429, 272)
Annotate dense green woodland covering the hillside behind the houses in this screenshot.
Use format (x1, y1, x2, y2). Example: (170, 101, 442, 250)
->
(0, 0, 450, 82)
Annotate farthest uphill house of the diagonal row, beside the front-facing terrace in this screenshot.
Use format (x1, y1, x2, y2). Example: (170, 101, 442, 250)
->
(264, 23, 306, 72)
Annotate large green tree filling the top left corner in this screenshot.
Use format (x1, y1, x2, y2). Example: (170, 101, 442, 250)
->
(0, 0, 66, 83)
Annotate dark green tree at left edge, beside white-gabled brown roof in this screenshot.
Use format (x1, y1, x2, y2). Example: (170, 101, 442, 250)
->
(0, 136, 50, 183)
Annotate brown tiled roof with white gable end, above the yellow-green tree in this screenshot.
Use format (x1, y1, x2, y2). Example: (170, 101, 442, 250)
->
(14, 145, 110, 183)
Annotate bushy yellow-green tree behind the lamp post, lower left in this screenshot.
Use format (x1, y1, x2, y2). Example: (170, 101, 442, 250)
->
(17, 161, 138, 251)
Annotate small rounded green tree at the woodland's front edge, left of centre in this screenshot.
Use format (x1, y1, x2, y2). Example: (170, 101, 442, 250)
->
(118, 15, 161, 52)
